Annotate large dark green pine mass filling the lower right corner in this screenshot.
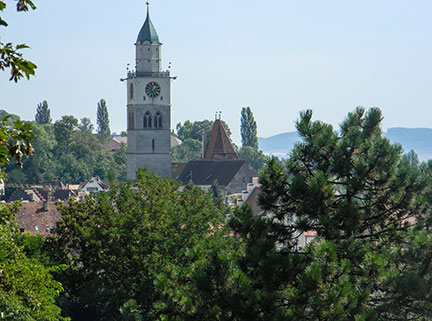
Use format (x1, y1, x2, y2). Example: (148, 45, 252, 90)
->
(172, 108, 432, 321)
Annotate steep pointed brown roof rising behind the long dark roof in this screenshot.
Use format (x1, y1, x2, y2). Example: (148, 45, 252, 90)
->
(204, 119, 238, 160)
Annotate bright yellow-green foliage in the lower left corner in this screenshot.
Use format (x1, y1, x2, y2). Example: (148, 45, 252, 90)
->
(0, 204, 64, 321)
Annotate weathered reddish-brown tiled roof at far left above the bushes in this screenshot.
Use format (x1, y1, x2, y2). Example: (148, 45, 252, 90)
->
(16, 202, 61, 235)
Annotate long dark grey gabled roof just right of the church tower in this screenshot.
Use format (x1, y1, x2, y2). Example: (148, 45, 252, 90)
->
(178, 159, 246, 186)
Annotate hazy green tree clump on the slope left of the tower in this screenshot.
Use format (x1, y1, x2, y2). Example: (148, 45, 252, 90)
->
(5, 116, 126, 184)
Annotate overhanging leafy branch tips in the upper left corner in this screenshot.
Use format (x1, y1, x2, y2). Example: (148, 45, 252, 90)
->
(0, 0, 37, 82)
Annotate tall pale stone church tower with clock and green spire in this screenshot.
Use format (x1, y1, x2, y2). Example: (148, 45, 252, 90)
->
(127, 2, 171, 179)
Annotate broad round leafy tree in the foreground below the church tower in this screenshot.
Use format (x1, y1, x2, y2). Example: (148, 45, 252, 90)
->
(50, 171, 225, 320)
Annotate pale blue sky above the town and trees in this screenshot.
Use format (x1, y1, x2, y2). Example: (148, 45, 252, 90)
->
(0, 0, 432, 143)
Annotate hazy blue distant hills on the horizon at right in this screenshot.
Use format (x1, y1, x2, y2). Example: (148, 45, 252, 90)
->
(258, 127, 432, 160)
